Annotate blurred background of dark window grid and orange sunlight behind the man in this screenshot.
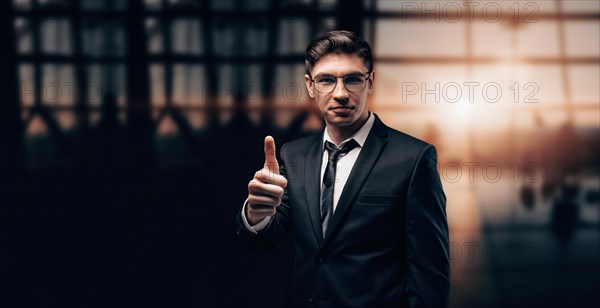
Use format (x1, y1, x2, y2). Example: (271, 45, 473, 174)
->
(0, 0, 600, 307)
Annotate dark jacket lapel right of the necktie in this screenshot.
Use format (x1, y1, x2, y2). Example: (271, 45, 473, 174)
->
(318, 115, 387, 249)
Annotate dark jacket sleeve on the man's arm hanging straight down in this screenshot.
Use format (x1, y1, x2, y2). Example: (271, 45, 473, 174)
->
(405, 145, 450, 308)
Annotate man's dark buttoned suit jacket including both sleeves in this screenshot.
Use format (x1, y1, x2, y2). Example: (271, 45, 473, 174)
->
(236, 116, 450, 308)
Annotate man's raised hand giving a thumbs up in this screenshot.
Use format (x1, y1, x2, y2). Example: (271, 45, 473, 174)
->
(246, 136, 287, 225)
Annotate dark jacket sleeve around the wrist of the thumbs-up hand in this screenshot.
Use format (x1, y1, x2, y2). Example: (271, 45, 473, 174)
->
(236, 144, 292, 252)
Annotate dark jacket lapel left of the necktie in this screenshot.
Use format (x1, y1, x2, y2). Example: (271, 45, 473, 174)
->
(304, 134, 323, 245)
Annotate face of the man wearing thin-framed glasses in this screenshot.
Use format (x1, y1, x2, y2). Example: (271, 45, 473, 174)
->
(304, 54, 375, 127)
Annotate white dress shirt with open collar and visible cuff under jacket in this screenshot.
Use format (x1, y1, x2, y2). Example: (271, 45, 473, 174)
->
(242, 112, 375, 233)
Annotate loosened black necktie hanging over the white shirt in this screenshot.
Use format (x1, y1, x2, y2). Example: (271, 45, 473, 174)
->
(321, 139, 358, 237)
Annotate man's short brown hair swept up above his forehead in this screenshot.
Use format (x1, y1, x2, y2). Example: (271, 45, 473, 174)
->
(304, 30, 373, 75)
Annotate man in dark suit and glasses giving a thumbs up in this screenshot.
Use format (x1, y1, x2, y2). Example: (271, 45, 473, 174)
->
(237, 31, 450, 308)
